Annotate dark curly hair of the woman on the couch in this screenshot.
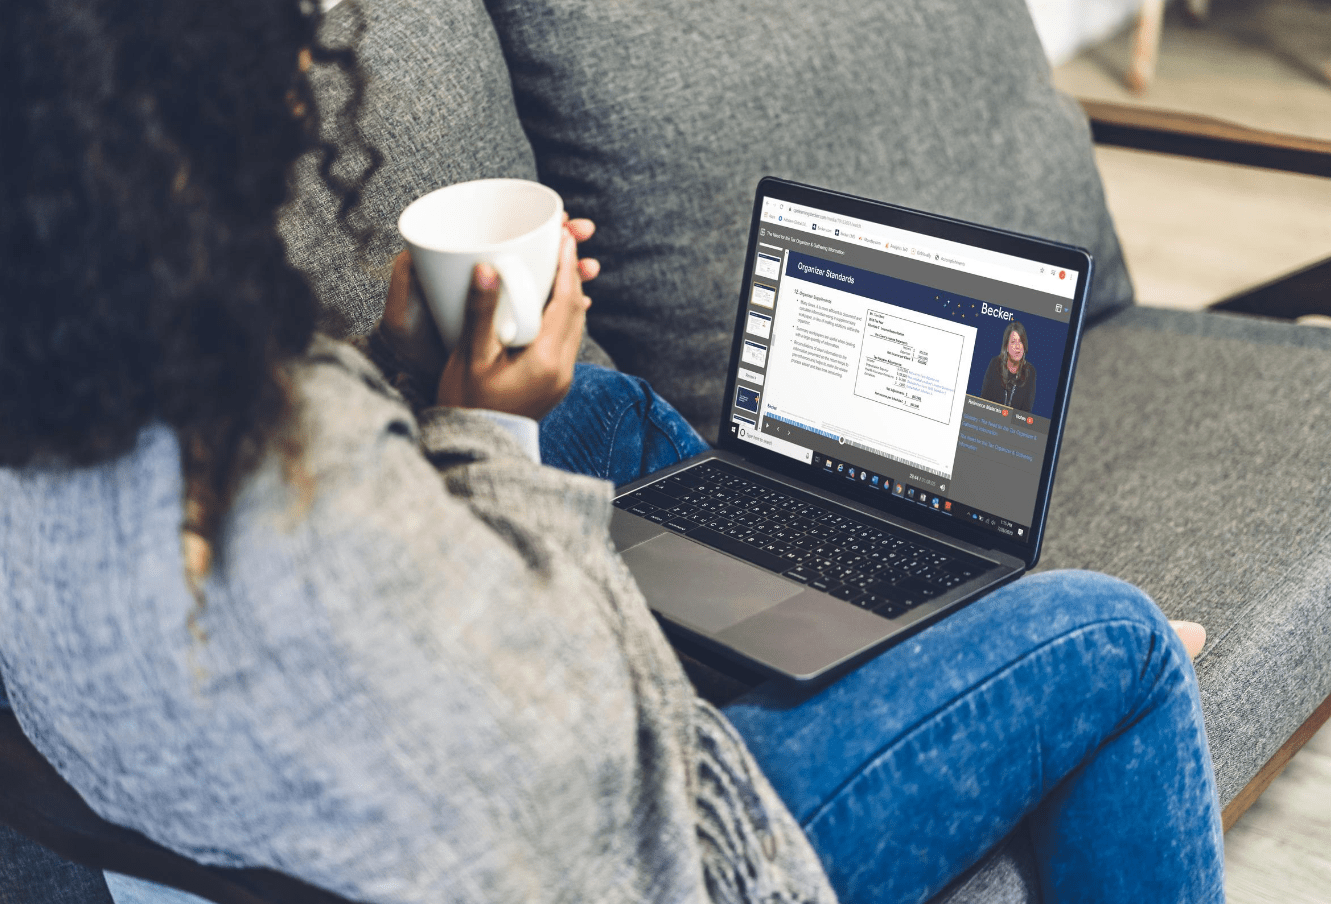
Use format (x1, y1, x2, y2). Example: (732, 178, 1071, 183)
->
(0, 0, 379, 551)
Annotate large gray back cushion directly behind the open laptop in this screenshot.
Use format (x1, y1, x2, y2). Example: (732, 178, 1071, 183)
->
(486, 0, 1131, 435)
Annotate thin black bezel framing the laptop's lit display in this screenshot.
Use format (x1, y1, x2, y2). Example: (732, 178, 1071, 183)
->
(717, 176, 1094, 567)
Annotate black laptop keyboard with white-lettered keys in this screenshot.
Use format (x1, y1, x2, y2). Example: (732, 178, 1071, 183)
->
(615, 461, 990, 618)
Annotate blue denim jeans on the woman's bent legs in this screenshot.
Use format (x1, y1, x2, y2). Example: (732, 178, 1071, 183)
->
(540, 367, 1225, 904)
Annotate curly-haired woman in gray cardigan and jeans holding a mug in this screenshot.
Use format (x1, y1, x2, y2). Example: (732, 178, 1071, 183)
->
(0, 0, 1223, 903)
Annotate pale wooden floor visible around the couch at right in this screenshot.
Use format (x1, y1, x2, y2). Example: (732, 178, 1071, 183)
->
(1054, 0, 1331, 904)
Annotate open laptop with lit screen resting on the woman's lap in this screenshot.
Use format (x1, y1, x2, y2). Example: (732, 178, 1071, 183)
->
(611, 178, 1091, 683)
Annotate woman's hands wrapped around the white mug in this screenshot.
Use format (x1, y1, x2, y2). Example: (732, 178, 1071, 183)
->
(379, 220, 600, 417)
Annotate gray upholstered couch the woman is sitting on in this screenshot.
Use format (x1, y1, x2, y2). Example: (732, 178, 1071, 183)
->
(275, 0, 1331, 903)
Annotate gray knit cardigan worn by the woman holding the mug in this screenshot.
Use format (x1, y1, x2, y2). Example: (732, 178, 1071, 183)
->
(0, 339, 833, 904)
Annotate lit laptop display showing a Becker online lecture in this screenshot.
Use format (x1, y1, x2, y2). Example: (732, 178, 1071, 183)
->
(729, 186, 1083, 545)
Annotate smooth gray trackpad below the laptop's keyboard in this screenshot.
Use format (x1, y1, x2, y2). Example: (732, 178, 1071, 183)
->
(623, 534, 804, 634)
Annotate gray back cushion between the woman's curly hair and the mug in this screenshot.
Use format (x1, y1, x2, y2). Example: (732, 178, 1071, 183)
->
(280, 0, 536, 336)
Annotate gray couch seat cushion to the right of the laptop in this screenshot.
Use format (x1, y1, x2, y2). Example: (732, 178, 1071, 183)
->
(1040, 308, 1331, 803)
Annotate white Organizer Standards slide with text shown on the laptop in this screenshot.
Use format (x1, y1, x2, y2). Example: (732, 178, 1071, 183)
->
(761, 258, 976, 478)
